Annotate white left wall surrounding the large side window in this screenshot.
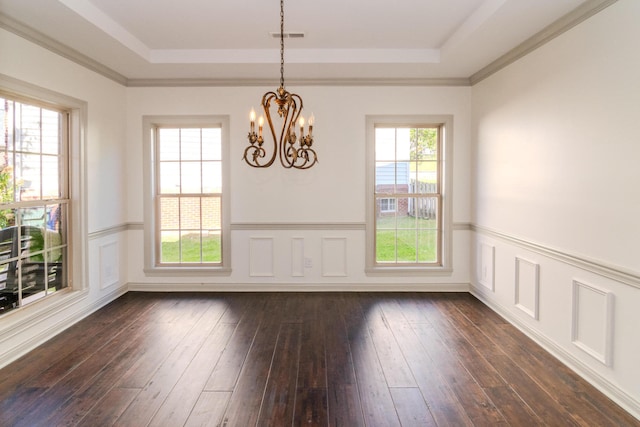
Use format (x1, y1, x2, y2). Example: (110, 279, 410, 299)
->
(0, 29, 127, 366)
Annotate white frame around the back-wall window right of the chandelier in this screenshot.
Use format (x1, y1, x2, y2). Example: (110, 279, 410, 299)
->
(365, 115, 453, 276)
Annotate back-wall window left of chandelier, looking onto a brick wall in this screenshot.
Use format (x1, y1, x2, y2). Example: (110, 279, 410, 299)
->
(145, 117, 229, 272)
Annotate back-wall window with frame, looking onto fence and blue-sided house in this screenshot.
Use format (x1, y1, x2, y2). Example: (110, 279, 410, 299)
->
(367, 117, 451, 273)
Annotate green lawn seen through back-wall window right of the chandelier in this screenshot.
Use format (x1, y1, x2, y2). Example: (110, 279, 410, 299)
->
(376, 216, 438, 263)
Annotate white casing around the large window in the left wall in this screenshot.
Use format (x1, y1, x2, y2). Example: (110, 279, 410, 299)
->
(0, 74, 89, 308)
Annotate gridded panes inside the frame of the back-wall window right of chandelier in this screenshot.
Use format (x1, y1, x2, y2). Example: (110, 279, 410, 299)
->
(372, 124, 443, 266)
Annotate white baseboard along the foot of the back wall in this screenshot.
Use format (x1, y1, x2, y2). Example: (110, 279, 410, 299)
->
(128, 282, 469, 292)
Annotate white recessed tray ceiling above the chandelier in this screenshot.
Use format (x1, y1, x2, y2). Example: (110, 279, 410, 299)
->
(0, 0, 603, 81)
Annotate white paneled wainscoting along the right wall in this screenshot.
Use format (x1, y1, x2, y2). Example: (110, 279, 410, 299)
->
(471, 226, 640, 420)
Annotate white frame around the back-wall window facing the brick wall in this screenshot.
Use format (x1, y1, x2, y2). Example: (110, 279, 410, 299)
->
(142, 116, 231, 277)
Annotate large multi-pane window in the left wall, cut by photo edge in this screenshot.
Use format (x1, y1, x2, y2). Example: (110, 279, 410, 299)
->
(0, 93, 70, 313)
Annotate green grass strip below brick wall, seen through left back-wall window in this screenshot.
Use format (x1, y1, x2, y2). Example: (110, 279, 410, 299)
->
(161, 233, 222, 263)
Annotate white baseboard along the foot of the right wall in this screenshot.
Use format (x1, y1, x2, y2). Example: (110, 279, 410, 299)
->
(469, 285, 640, 420)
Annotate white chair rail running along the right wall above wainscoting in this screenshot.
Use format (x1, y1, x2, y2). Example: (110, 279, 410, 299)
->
(471, 224, 640, 288)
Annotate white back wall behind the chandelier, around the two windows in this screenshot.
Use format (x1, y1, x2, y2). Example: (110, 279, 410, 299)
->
(127, 84, 471, 290)
